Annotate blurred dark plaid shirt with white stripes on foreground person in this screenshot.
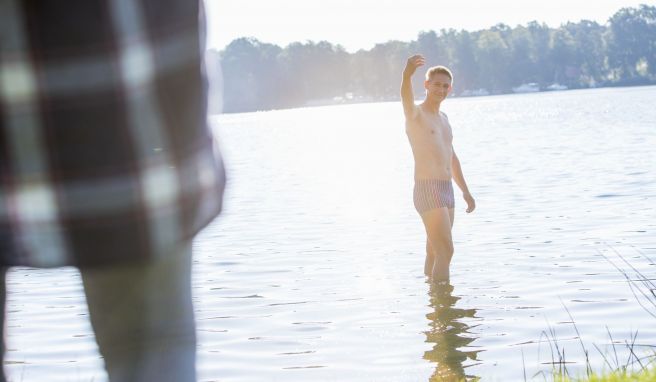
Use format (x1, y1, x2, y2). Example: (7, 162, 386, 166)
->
(0, 0, 224, 267)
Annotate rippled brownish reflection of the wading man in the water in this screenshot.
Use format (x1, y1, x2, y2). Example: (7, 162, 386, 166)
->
(424, 283, 478, 382)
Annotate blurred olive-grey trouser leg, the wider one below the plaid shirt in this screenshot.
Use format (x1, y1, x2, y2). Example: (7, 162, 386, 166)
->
(80, 246, 196, 382)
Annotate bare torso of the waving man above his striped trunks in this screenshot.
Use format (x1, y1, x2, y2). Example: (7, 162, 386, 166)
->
(405, 106, 453, 180)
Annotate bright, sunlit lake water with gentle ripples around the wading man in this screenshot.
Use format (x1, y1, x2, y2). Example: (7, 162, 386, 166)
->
(5, 87, 656, 381)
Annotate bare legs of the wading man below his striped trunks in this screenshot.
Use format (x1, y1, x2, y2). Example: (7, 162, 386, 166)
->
(421, 207, 453, 281)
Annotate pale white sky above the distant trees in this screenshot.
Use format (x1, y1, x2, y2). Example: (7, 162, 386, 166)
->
(205, 0, 656, 52)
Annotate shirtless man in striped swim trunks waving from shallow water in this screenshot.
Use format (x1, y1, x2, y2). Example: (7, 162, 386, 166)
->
(401, 55, 476, 282)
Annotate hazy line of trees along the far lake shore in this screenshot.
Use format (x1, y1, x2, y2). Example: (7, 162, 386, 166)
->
(207, 5, 656, 112)
